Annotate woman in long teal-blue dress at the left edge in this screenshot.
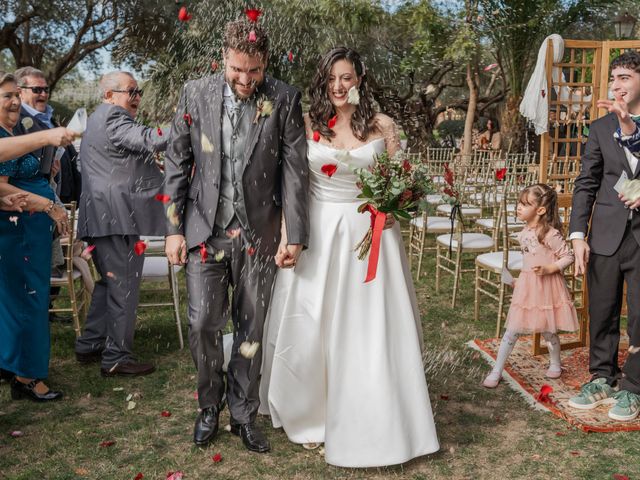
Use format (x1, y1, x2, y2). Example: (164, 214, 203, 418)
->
(0, 72, 68, 402)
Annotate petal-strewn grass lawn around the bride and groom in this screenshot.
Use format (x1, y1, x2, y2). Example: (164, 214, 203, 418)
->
(0, 248, 640, 480)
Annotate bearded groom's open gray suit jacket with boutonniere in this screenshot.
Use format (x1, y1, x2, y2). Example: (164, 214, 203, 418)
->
(165, 74, 309, 255)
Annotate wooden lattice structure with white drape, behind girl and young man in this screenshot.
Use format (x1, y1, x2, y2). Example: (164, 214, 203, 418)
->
(534, 40, 640, 355)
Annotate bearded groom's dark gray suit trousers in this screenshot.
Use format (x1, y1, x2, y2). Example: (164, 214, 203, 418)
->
(186, 224, 276, 423)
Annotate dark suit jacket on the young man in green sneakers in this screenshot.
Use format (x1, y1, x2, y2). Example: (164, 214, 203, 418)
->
(569, 113, 640, 256)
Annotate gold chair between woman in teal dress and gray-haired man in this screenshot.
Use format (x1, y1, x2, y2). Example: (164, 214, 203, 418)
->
(49, 202, 91, 337)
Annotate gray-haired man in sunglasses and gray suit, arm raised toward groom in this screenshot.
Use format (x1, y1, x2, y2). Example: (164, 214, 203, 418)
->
(76, 71, 167, 377)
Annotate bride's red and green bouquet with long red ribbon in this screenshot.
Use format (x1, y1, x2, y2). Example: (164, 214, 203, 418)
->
(355, 151, 434, 283)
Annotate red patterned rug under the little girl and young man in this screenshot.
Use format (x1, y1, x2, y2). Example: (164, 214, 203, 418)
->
(467, 334, 640, 432)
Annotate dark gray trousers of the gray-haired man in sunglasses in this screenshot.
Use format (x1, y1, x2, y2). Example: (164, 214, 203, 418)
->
(76, 235, 144, 368)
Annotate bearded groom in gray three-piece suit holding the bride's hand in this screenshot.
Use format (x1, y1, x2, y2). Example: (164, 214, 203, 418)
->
(165, 20, 309, 453)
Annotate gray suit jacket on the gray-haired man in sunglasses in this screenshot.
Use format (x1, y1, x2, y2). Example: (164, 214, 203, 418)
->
(78, 103, 167, 238)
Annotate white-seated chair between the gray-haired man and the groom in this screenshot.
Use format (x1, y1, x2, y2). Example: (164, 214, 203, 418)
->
(138, 237, 184, 350)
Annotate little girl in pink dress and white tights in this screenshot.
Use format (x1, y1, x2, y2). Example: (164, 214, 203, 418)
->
(483, 183, 578, 388)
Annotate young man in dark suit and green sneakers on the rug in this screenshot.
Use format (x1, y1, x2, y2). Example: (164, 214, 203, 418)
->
(569, 51, 640, 421)
